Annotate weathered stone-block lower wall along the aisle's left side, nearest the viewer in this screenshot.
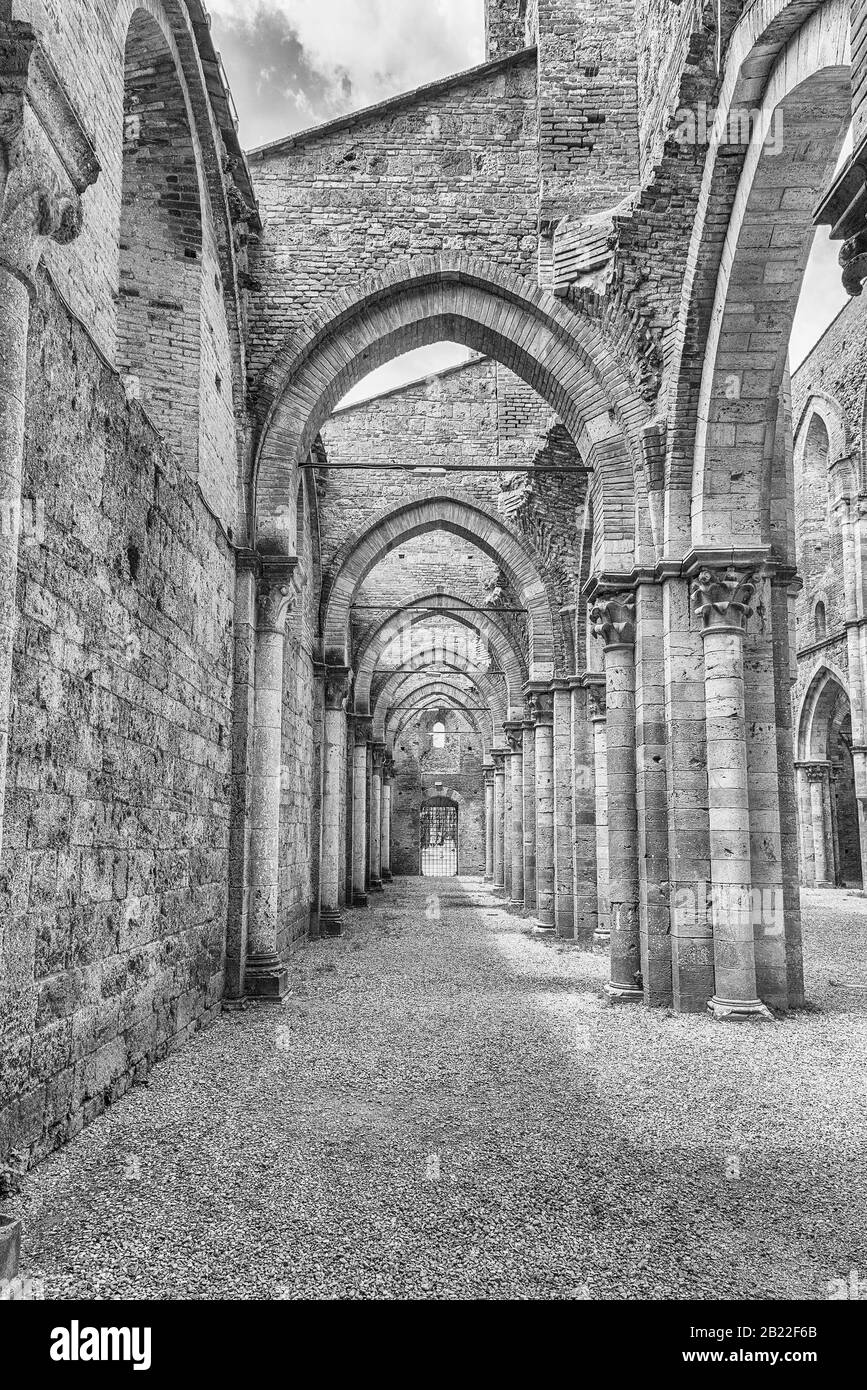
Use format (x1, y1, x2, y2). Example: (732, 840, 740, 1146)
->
(0, 281, 233, 1158)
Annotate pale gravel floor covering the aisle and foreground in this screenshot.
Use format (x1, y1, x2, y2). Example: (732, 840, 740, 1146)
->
(6, 878, 867, 1298)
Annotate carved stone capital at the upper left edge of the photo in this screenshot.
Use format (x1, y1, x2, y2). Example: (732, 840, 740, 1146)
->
(0, 21, 100, 289)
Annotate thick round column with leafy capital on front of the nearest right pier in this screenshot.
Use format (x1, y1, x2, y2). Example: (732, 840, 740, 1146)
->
(692, 566, 768, 1019)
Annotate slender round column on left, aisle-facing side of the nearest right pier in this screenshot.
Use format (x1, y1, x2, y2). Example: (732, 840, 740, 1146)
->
(591, 592, 643, 1004)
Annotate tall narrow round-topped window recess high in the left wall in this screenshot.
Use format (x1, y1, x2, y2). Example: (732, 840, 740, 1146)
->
(117, 10, 201, 473)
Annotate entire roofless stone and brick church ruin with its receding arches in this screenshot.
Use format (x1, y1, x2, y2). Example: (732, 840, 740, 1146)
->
(0, 0, 867, 1161)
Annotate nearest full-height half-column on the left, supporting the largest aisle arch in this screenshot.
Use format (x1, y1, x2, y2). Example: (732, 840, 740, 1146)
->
(245, 556, 300, 1001)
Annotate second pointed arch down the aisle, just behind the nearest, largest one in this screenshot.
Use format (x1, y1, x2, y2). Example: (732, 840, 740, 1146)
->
(327, 496, 556, 680)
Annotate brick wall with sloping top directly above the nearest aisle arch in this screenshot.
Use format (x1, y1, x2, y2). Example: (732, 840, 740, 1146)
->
(244, 54, 538, 371)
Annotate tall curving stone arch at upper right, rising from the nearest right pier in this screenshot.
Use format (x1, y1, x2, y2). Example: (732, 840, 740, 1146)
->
(666, 0, 850, 555)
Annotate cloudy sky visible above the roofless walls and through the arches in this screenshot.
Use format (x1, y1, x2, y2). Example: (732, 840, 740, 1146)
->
(206, 0, 846, 399)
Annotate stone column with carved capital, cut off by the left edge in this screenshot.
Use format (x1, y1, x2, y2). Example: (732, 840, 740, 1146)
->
(0, 32, 100, 849)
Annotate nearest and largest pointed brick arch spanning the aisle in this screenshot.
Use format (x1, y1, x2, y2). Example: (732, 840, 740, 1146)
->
(253, 256, 647, 567)
